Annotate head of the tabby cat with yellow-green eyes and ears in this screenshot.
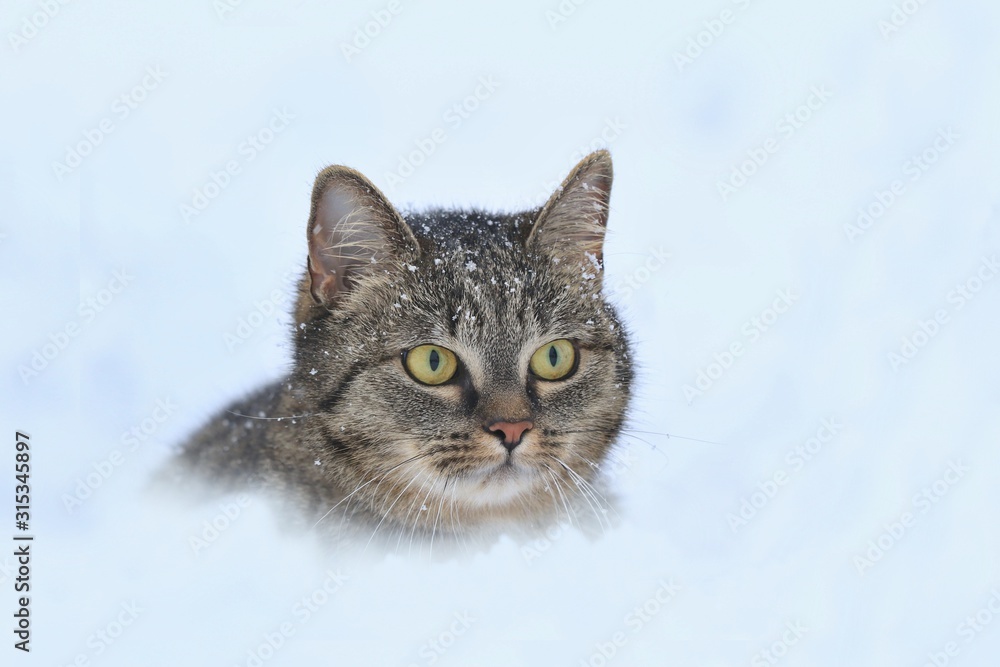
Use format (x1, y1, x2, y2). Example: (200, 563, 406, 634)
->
(293, 151, 632, 532)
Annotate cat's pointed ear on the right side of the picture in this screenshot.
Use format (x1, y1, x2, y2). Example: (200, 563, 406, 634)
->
(527, 150, 614, 263)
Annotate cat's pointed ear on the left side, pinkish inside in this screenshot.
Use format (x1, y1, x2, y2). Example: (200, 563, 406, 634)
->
(306, 166, 419, 307)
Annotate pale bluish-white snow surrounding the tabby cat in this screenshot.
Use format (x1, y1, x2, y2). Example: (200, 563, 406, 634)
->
(0, 0, 1000, 667)
